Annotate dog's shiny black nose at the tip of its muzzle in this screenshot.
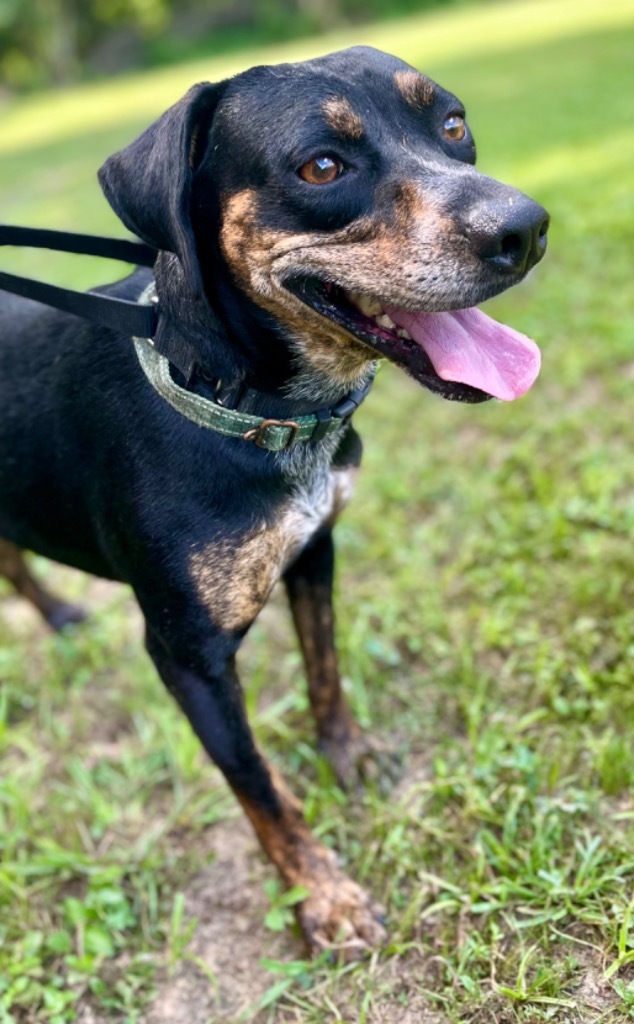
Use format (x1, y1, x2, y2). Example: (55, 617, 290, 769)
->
(465, 195, 549, 274)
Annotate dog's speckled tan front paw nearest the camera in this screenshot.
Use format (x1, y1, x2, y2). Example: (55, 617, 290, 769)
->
(296, 855, 387, 964)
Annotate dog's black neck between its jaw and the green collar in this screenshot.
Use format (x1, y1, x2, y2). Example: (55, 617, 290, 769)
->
(155, 252, 375, 419)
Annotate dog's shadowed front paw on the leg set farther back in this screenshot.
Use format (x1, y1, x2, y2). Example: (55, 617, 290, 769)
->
(320, 727, 400, 793)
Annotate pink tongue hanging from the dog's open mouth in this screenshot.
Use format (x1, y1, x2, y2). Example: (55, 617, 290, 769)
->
(385, 307, 541, 401)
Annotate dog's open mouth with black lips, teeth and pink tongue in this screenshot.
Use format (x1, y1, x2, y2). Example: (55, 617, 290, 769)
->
(287, 278, 541, 402)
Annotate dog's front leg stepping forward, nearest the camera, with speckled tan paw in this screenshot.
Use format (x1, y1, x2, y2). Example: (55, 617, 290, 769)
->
(147, 631, 385, 959)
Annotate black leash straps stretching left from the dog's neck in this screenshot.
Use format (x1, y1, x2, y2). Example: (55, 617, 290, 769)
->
(0, 224, 159, 338)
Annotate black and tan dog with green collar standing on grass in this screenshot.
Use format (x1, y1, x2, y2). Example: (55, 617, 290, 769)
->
(0, 48, 547, 955)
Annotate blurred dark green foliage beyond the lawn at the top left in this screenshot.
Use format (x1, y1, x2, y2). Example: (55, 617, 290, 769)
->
(0, 0, 469, 89)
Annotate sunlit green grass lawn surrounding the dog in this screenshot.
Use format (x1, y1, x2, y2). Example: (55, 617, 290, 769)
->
(0, 0, 634, 1024)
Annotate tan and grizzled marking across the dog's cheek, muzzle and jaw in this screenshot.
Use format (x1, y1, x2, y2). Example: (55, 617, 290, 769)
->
(220, 176, 472, 387)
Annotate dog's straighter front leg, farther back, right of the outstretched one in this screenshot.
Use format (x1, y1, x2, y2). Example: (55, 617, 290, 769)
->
(284, 531, 394, 788)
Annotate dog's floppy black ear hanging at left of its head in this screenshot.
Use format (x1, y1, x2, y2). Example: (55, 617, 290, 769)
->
(98, 82, 224, 295)
